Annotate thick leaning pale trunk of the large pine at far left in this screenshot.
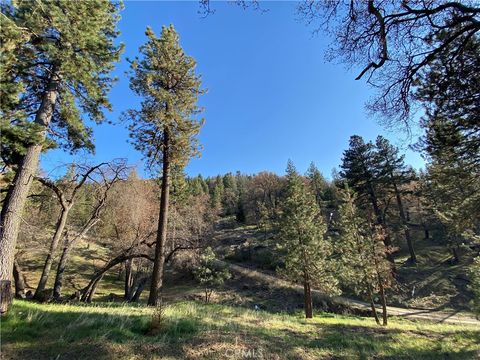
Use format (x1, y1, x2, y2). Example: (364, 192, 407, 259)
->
(0, 68, 60, 310)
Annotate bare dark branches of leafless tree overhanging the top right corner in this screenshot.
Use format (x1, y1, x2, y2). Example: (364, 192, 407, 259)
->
(298, 0, 480, 129)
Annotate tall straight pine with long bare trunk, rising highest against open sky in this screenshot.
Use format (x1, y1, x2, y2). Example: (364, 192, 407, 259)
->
(126, 25, 204, 305)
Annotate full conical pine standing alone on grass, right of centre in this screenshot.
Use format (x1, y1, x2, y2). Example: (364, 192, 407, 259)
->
(279, 161, 337, 318)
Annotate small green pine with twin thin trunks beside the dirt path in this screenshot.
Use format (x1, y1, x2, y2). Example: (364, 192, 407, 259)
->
(336, 187, 393, 325)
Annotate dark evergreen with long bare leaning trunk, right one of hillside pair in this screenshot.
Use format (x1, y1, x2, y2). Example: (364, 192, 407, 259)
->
(375, 136, 417, 264)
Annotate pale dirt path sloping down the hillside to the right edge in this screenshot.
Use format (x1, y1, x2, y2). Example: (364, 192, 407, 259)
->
(218, 261, 480, 328)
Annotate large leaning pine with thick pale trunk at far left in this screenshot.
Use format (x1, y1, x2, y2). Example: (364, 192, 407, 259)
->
(0, 0, 121, 310)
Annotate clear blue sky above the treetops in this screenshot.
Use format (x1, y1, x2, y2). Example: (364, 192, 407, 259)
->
(42, 1, 423, 177)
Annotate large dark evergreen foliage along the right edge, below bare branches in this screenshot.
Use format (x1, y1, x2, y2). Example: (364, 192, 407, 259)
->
(416, 31, 480, 261)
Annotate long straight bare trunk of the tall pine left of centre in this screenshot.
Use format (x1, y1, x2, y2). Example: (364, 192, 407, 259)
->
(148, 129, 170, 306)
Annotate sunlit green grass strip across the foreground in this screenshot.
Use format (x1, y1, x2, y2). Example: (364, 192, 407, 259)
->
(1, 301, 480, 360)
